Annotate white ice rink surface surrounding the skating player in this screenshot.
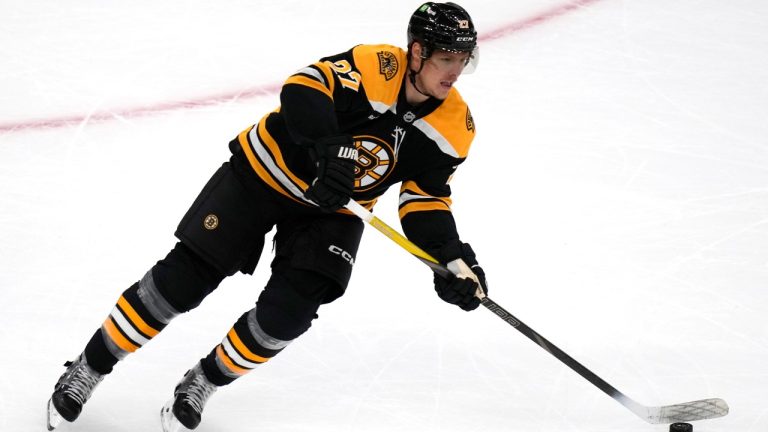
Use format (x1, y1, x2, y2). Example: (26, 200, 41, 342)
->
(0, 0, 768, 432)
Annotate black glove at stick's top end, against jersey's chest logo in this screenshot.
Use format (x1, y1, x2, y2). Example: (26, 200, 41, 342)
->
(304, 135, 357, 213)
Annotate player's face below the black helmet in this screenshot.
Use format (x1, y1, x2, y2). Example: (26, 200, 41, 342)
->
(416, 50, 470, 100)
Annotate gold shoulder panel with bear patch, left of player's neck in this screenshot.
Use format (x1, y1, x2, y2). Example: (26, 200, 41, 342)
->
(352, 45, 407, 113)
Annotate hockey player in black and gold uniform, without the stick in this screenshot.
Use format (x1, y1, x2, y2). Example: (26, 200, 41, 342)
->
(48, 3, 487, 432)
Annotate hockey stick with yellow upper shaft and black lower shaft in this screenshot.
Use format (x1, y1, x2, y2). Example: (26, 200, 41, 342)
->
(346, 200, 728, 424)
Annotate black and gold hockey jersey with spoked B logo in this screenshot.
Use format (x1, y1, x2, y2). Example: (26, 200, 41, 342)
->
(238, 45, 475, 251)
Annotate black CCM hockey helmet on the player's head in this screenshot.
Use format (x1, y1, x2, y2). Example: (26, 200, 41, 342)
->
(408, 2, 477, 64)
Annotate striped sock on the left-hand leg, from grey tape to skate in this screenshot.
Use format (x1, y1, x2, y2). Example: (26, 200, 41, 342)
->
(85, 271, 179, 374)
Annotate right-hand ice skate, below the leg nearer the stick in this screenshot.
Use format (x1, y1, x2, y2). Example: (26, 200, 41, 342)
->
(160, 362, 217, 432)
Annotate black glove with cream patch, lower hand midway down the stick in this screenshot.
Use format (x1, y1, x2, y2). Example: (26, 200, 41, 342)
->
(435, 240, 488, 311)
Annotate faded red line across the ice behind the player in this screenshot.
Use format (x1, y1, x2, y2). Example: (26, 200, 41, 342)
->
(0, 0, 600, 132)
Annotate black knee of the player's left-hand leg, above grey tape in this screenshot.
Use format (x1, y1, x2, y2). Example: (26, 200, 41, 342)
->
(151, 243, 224, 312)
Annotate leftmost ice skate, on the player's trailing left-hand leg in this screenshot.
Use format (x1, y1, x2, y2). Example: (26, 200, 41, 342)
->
(47, 354, 104, 431)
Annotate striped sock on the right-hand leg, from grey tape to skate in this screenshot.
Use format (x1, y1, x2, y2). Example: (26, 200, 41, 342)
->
(201, 308, 291, 386)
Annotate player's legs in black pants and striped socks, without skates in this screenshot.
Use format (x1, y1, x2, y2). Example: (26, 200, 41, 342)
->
(86, 146, 363, 385)
